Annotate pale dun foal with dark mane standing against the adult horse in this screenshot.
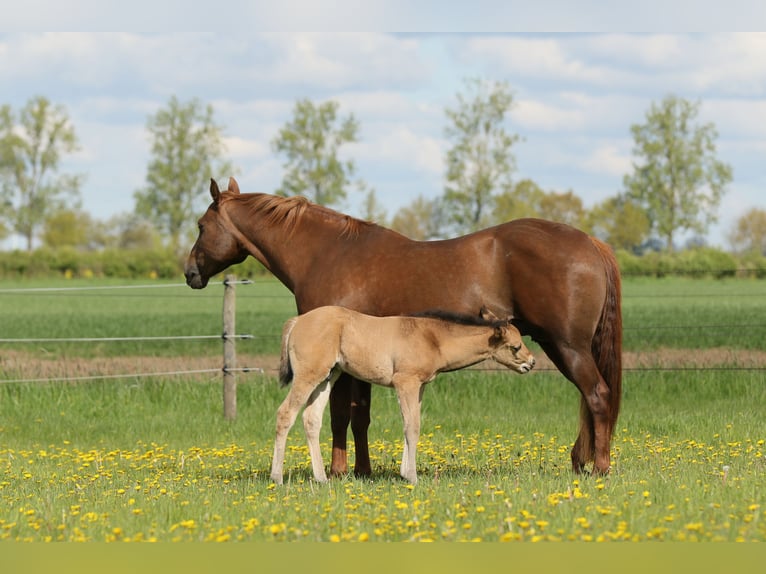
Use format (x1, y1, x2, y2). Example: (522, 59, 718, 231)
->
(271, 306, 535, 484)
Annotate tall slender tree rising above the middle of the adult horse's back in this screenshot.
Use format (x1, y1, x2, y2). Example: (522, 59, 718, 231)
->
(444, 79, 519, 233)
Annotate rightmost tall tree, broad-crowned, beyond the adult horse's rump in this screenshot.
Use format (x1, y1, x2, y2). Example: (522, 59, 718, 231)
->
(624, 95, 732, 251)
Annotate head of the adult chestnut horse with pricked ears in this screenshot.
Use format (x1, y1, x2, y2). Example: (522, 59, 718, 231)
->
(184, 177, 247, 289)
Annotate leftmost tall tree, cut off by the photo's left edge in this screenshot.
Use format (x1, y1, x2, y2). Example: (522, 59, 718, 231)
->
(0, 96, 82, 250)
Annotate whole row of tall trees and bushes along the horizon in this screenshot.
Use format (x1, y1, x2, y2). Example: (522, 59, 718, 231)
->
(0, 79, 766, 262)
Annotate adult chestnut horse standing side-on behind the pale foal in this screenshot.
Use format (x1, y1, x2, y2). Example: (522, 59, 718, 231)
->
(184, 178, 622, 475)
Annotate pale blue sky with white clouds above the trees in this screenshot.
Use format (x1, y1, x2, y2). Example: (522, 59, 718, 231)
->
(0, 13, 766, 247)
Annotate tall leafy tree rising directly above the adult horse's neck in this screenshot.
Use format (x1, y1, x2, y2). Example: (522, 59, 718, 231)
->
(271, 99, 359, 205)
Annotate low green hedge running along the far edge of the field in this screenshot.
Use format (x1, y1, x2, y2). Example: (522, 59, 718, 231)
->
(0, 248, 766, 279)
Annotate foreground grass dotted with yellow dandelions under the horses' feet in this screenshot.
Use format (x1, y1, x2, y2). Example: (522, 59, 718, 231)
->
(0, 372, 766, 541)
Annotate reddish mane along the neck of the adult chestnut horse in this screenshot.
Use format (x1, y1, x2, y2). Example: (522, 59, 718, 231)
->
(232, 193, 375, 237)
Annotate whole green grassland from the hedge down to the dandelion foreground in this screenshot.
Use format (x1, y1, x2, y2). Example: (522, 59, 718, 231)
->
(0, 278, 766, 542)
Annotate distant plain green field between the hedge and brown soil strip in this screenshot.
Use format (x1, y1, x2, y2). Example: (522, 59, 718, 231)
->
(0, 278, 766, 356)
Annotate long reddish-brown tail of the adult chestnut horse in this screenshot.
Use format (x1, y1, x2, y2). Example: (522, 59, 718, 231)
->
(582, 237, 622, 438)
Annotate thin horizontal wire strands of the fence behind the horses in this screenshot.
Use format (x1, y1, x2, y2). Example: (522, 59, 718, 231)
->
(0, 279, 766, 383)
